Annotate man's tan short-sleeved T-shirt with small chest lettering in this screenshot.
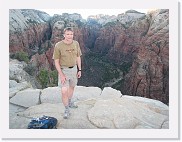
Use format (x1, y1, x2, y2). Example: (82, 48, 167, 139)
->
(53, 40, 82, 67)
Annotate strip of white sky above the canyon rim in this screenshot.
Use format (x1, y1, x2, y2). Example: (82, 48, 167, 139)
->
(38, 9, 151, 19)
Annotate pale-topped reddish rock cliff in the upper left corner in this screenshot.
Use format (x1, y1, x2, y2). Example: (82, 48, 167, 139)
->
(9, 9, 50, 54)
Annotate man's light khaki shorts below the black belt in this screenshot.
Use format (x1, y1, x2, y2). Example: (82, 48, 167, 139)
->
(58, 66, 78, 88)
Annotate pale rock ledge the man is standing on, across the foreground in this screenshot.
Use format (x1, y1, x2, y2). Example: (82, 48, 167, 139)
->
(9, 86, 169, 129)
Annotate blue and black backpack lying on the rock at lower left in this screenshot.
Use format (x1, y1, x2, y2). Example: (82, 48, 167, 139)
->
(28, 115, 57, 129)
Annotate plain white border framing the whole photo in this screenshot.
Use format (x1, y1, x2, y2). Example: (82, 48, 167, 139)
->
(0, 0, 180, 140)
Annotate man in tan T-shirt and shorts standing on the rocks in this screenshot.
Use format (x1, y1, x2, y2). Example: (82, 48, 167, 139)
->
(53, 27, 82, 119)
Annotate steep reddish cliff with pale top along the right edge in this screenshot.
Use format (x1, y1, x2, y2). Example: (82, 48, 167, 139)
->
(122, 10, 169, 103)
